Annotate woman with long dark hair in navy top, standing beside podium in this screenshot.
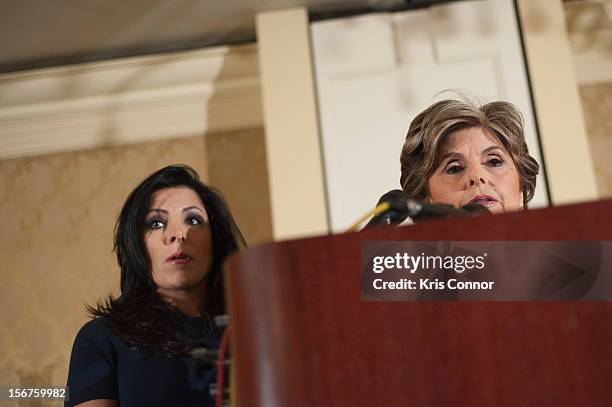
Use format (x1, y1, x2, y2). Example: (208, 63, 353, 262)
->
(65, 165, 244, 407)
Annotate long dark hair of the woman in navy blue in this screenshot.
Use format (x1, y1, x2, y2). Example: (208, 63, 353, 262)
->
(88, 164, 245, 355)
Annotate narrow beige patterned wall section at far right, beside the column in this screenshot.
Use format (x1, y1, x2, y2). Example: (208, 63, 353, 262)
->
(580, 83, 612, 199)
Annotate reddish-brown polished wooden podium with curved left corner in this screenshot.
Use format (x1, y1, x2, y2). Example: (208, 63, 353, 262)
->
(225, 201, 612, 407)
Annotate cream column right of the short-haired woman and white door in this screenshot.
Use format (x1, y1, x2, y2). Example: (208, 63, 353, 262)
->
(518, 0, 597, 204)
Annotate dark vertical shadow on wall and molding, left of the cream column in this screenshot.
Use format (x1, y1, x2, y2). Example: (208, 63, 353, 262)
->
(205, 49, 273, 246)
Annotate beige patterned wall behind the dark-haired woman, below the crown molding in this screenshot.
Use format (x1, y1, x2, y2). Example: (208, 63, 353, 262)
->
(0, 129, 271, 406)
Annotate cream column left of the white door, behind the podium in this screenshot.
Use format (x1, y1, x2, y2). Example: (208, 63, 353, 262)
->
(256, 8, 328, 240)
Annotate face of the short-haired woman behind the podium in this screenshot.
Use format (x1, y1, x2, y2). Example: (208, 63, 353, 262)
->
(429, 127, 523, 213)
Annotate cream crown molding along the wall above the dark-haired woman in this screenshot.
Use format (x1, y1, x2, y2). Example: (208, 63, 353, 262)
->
(0, 45, 262, 159)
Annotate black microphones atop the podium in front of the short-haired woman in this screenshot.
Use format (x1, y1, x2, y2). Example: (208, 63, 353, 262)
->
(365, 189, 491, 228)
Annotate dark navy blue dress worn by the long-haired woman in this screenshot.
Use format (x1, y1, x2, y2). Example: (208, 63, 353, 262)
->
(64, 317, 219, 407)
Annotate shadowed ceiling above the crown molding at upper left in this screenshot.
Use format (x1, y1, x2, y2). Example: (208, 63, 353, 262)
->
(0, 0, 448, 72)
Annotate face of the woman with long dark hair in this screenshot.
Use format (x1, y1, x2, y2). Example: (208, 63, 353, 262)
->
(144, 187, 212, 297)
